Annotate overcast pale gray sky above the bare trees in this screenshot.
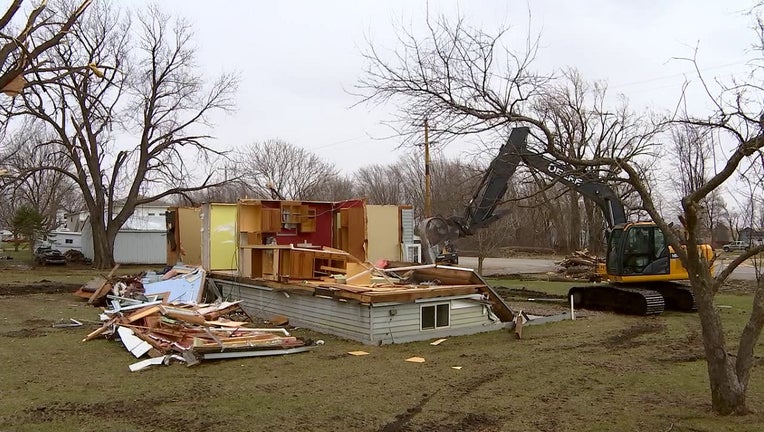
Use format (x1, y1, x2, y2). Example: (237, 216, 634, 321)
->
(152, 0, 754, 172)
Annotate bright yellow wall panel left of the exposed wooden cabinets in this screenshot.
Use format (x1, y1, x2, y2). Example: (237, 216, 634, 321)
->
(207, 204, 238, 270)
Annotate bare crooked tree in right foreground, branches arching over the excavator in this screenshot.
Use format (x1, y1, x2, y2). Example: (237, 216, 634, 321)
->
(358, 11, 764, 414)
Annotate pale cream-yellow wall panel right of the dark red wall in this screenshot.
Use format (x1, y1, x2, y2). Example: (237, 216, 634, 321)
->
(366, 205, 401, 264)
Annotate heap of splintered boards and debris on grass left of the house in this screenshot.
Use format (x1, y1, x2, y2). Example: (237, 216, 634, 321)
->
(75, 267, 314, 371)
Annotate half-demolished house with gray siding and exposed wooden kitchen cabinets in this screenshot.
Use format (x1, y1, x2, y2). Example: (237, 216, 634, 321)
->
(168, 200, 513, 344)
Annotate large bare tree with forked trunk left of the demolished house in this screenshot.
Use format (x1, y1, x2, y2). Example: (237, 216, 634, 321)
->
(10, 3, 237, 268)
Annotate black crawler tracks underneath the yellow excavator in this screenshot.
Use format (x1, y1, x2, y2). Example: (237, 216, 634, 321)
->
(568, 283, 696, 315)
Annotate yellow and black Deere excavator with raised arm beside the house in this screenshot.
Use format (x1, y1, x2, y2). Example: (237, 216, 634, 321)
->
(419, 127, 713, 315)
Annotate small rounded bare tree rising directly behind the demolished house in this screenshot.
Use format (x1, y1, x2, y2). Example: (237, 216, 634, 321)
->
(239, 139, 339, 200)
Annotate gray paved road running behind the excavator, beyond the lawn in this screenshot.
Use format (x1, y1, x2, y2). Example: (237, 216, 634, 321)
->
(459, 257, 756, 280)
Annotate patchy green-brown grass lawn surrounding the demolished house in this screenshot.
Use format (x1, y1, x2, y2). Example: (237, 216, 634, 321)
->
(0, 267, 764, 432)
